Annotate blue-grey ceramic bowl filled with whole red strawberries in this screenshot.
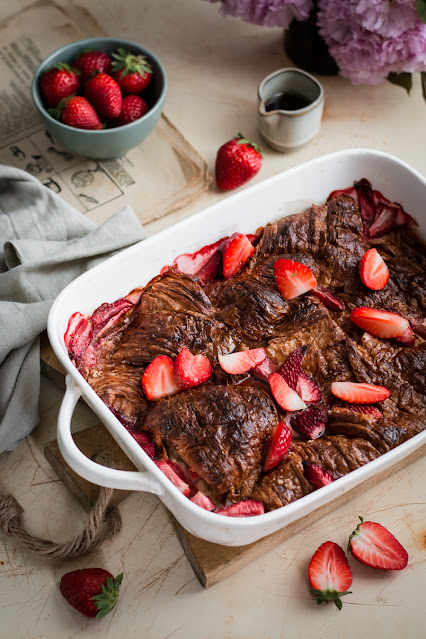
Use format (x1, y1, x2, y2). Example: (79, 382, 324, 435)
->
(31, 38, 167, 160)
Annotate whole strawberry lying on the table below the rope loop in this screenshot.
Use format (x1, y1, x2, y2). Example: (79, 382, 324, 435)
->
(59, 568, 123, 619)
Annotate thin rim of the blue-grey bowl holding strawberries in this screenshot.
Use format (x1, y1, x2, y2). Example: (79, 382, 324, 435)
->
(31, 36, 168, 137)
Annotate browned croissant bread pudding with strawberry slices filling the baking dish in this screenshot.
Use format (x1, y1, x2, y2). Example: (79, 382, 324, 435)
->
(65, 179, 426, 516)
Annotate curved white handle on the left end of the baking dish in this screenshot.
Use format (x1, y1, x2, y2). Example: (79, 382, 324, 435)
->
(58, 375, 164, 495)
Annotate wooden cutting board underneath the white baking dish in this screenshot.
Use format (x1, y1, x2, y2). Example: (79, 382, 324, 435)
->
(41, 334, 426, 588)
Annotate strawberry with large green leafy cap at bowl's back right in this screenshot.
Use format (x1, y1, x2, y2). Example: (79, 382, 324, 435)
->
(112, 49, 152, 95)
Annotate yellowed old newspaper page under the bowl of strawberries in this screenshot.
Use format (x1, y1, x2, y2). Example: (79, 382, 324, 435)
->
(0, 2, 210, 223)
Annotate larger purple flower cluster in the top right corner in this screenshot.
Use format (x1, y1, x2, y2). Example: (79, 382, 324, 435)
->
(318, 0, 426, 84)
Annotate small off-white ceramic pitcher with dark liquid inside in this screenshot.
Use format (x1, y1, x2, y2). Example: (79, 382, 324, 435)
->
(257, 68, 324, 151)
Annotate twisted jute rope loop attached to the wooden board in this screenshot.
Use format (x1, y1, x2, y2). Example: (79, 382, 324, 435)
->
(0, 456, 122, 559)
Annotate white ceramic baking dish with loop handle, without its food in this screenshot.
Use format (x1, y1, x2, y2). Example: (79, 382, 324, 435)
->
(48, 149, 426, 546)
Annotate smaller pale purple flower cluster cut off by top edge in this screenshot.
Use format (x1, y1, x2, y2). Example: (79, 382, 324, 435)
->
(209, 0, 313, 29)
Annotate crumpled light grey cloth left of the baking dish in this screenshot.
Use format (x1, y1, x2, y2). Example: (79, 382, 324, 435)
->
(0, 165, 145, 452)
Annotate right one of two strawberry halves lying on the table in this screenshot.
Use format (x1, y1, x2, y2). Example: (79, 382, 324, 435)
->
(348, 517, 408, 570)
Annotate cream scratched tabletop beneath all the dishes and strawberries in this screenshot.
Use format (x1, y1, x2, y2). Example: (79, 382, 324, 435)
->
(0, 0, 426, 639)
